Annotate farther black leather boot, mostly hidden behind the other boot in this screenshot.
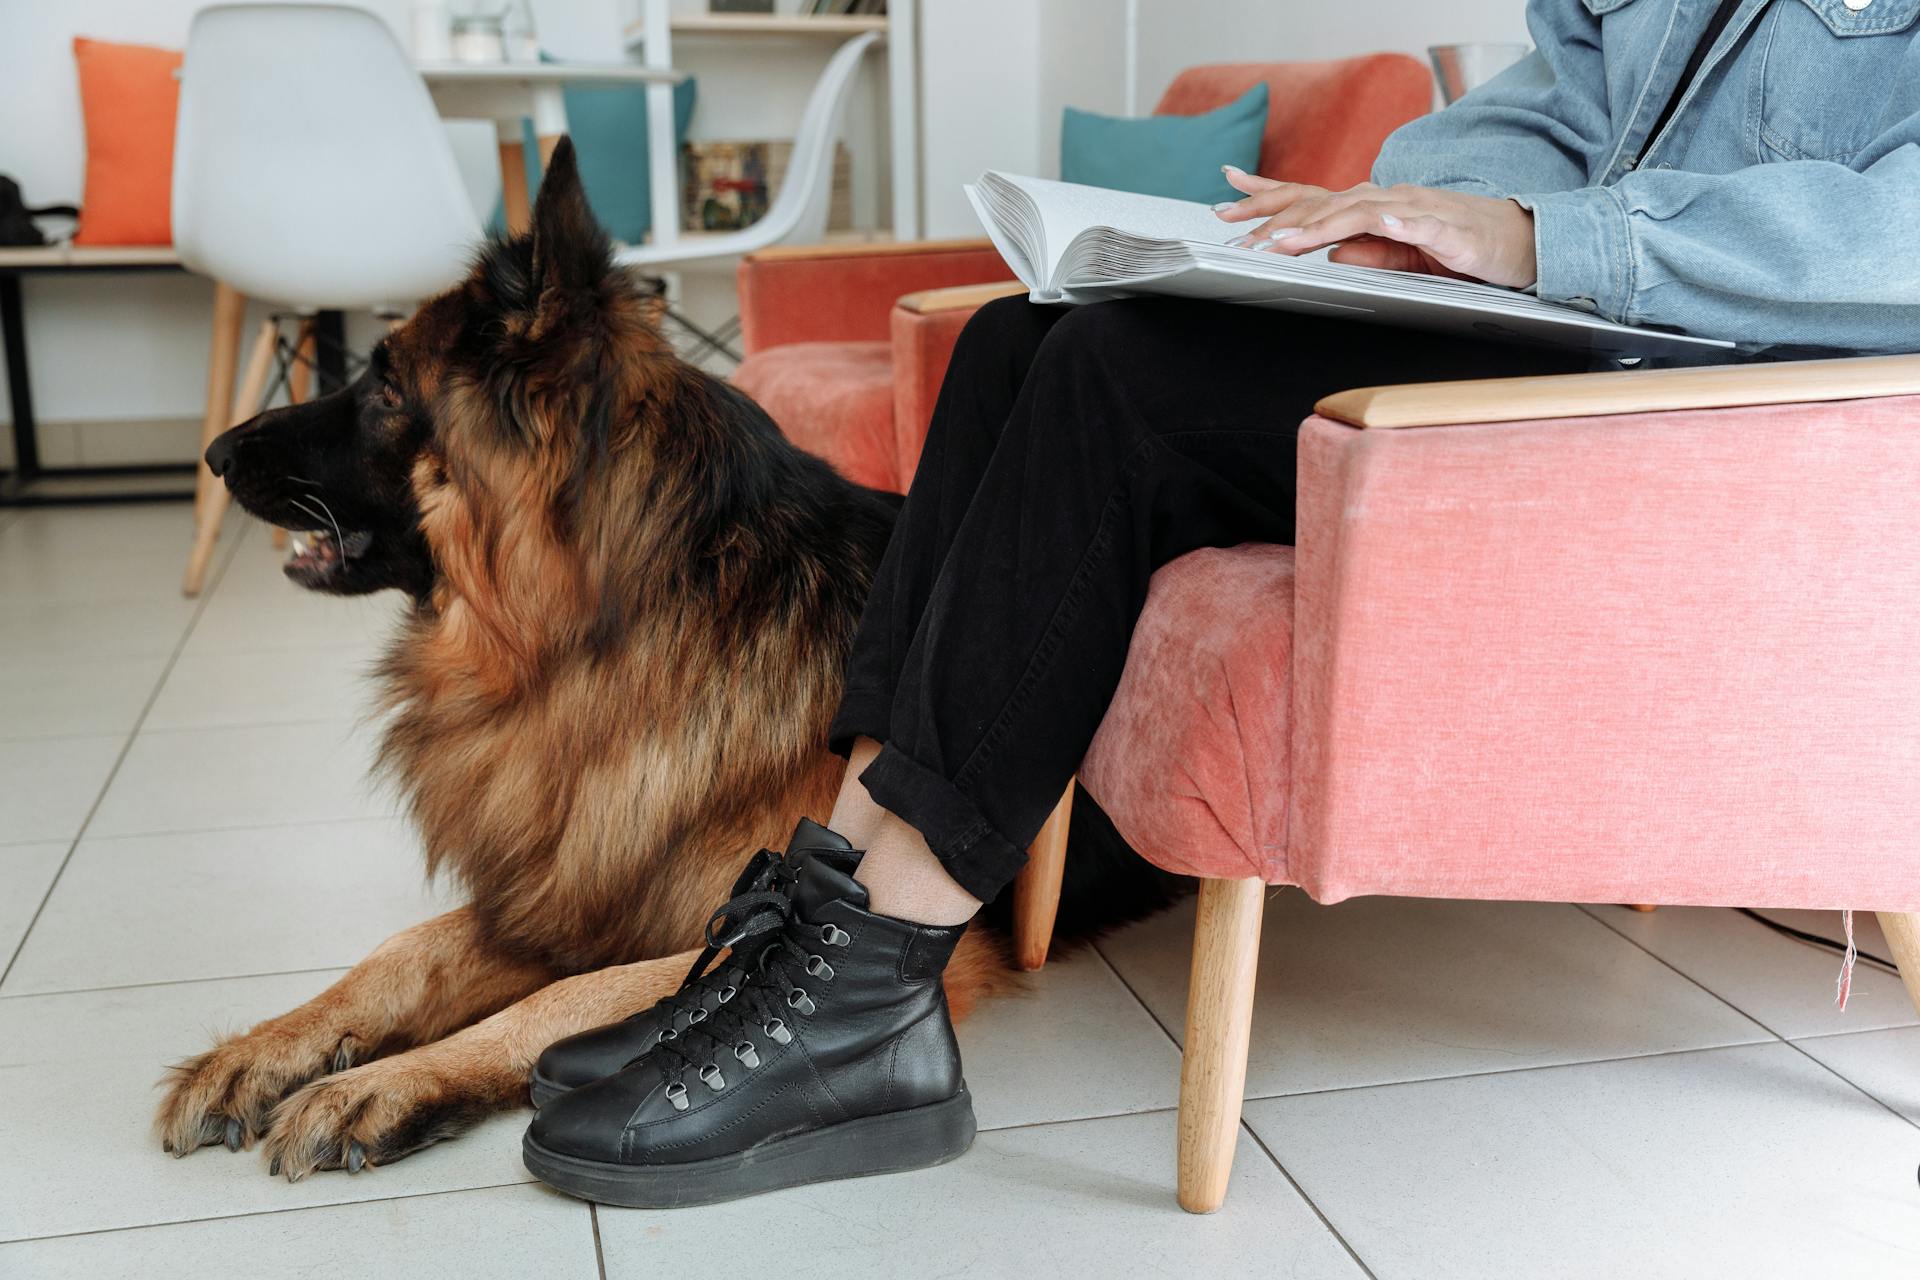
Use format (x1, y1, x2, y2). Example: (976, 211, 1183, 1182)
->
(528, 818, 829, 1107)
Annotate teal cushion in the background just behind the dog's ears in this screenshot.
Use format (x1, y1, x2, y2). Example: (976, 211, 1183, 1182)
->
(488, 69, 695, 244)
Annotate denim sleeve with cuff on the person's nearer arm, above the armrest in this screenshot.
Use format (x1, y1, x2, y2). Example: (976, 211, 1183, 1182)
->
(1515, 138, 1920, 351)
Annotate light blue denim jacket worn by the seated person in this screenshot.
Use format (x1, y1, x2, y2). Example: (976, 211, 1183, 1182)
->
(1373, 0, 1920, 351)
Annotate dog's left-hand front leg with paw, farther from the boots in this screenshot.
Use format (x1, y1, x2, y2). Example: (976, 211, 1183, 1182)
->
(156, 908, 553, 1155)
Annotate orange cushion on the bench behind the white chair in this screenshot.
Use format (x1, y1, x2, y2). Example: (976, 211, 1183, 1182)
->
(73, 36, 180, 244)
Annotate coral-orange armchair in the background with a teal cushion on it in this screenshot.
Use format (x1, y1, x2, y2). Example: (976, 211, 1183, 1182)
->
(733, 54, 1432, 491)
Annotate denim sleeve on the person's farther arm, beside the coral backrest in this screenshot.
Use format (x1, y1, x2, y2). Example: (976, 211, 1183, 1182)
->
(1373, 0, 1611, 198)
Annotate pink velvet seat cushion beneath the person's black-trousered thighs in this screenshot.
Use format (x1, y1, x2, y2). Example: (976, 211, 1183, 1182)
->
(1081, 543, 1294, 881)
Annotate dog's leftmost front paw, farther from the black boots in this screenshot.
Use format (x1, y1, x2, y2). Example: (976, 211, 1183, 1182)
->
(156, 1025, 357, 1155)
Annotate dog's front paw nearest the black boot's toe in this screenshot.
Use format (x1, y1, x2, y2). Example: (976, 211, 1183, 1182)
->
(265, 1052, 503, 1182)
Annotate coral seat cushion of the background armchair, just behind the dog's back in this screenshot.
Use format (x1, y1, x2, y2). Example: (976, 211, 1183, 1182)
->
(733, 342, 899, 489)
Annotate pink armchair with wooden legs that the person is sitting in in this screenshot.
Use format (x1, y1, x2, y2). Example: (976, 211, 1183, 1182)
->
(1018, 357, 1920, 1211)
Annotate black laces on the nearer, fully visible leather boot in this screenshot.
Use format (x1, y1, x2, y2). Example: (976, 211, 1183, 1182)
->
(653, 898, 851, 1111)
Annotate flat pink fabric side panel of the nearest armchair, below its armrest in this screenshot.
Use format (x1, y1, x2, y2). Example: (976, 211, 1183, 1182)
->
(1282, 395, 1920, 912)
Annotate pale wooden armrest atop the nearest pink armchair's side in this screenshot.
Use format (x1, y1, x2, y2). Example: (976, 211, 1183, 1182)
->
(1313, 355, 1920, 428)
